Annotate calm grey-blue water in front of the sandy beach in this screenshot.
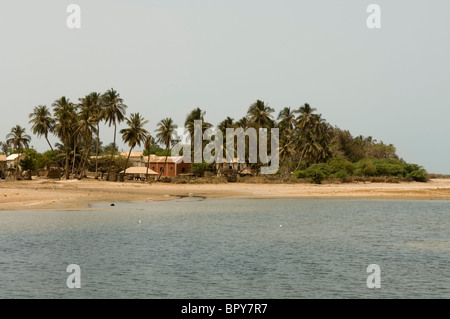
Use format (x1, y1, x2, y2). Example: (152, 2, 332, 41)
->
(0, 198, 450, 299)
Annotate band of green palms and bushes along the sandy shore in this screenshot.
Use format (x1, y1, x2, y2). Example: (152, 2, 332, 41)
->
(0, 89, 428, 183)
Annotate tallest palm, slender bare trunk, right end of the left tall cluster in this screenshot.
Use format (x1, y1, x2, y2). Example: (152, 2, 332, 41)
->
(102, 89, 127, 180)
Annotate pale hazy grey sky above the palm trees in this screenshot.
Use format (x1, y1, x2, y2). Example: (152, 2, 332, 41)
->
(0, 0, 450, 173)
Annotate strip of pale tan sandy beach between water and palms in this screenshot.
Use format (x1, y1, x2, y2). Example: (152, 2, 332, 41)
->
(0, 179, 450, 210)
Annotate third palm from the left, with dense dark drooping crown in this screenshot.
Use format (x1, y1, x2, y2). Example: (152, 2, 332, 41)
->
(52, 96, 76, 179)
